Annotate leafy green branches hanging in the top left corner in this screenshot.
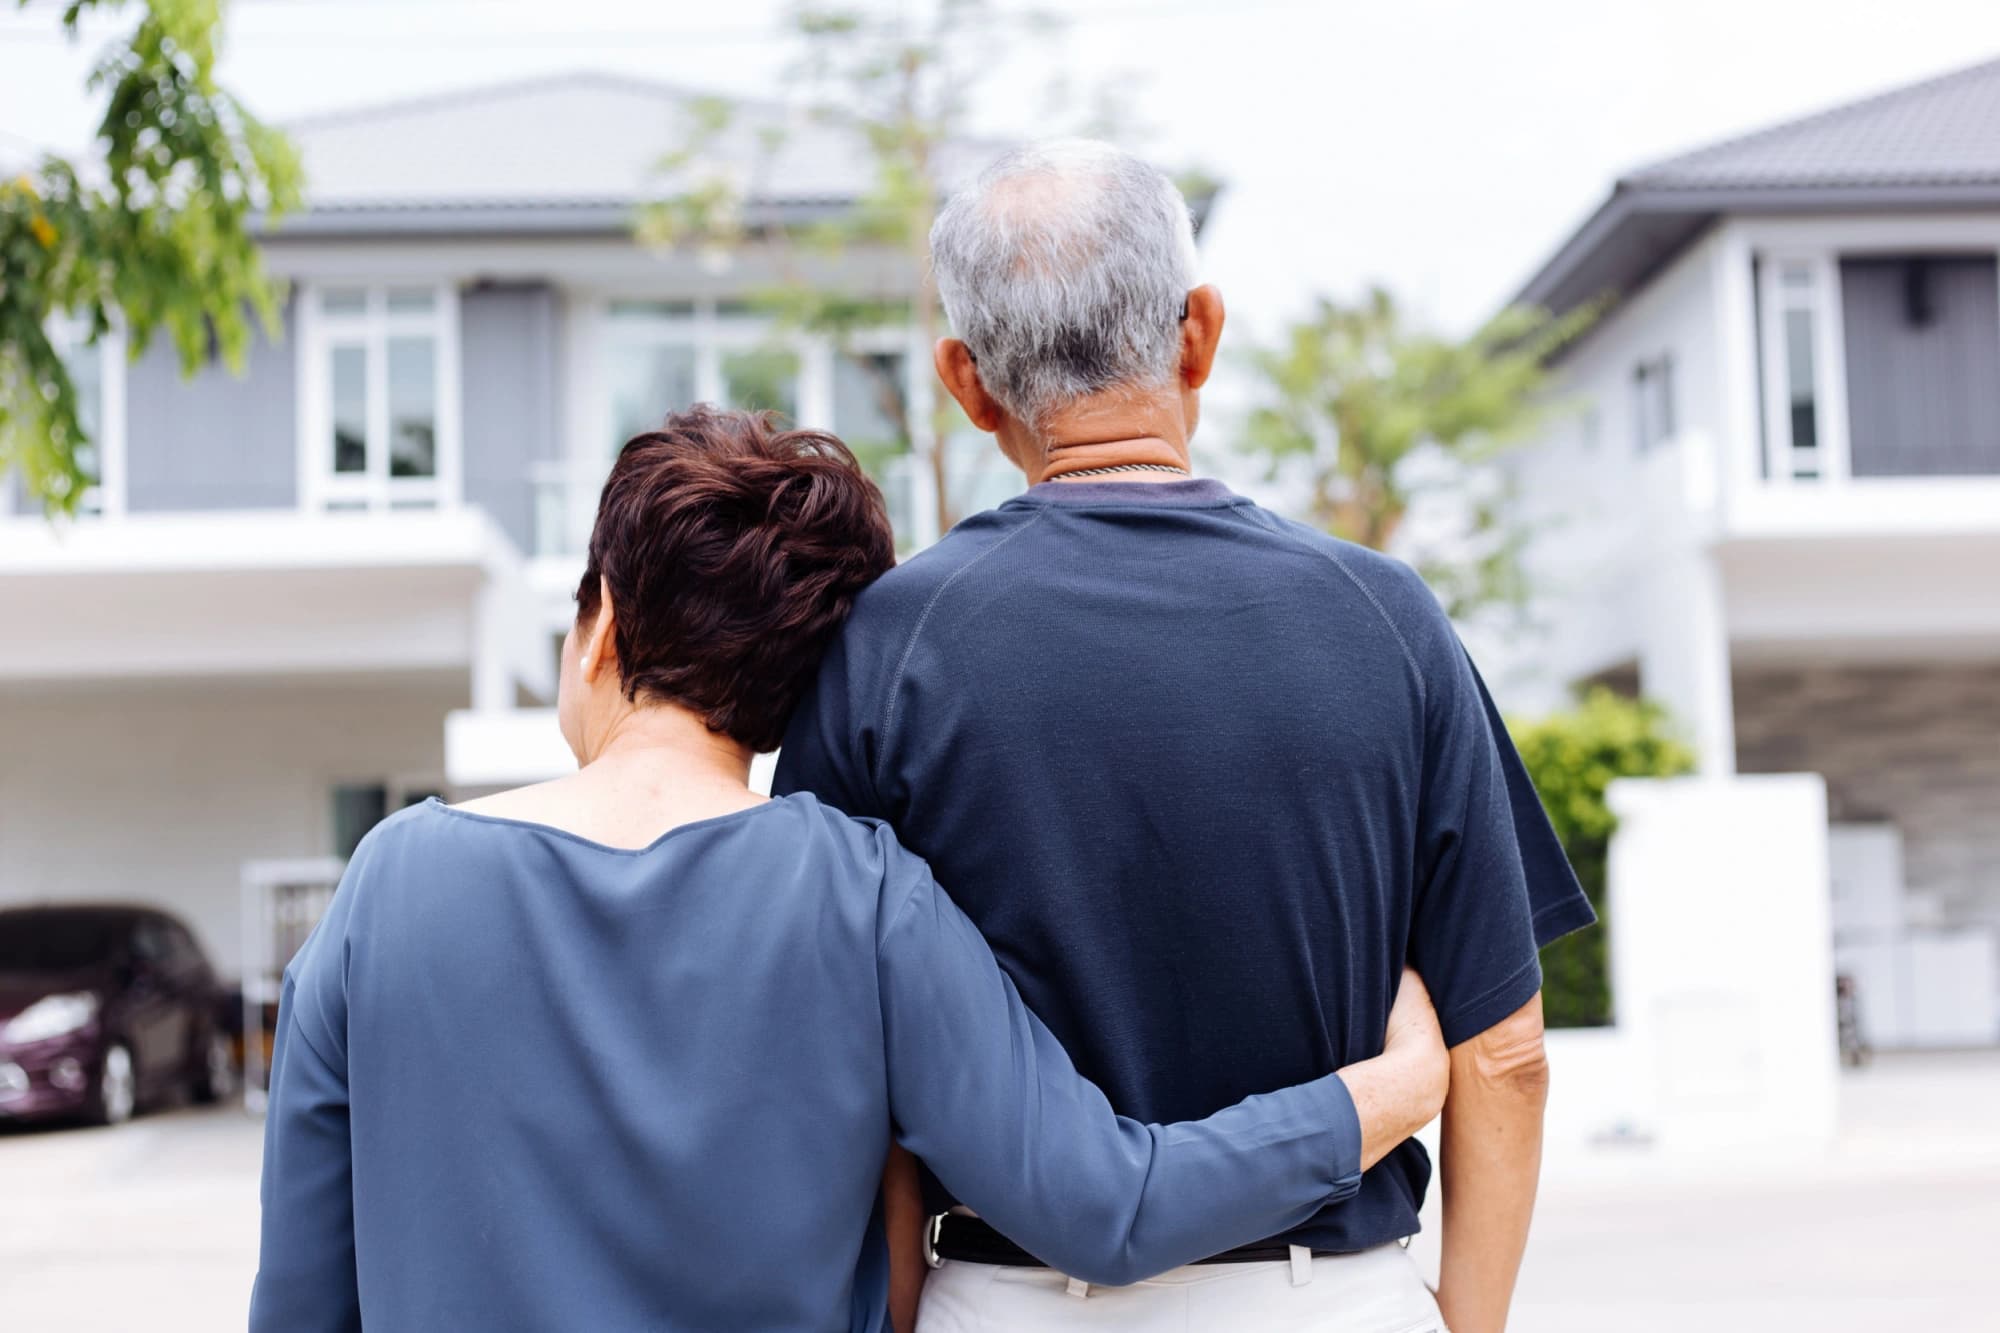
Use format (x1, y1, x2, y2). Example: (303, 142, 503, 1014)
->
(0, 0, 300, 512)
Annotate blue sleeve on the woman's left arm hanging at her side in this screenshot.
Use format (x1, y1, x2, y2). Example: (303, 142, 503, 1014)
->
(250, 979, 362, 1333)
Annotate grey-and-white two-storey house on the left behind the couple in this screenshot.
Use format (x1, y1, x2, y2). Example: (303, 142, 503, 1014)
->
(0, 76, 1012, 973)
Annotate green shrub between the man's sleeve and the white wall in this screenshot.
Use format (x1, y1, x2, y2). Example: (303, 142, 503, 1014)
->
(1508, 687, 1694, 1027)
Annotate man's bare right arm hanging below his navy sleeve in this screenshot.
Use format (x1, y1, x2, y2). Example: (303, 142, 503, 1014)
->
(1438, 993, 1548, 1333)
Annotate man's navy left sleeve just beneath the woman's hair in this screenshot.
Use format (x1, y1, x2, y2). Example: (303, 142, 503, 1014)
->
(772, 620, 888, 819)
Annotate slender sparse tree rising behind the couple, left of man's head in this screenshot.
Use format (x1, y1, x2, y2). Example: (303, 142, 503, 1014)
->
(638, 0, 1214, 532)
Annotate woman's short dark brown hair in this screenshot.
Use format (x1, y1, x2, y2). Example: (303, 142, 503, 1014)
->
(576, 404, 896, 753)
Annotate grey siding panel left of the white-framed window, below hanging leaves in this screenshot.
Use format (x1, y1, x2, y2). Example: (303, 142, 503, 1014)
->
(126, 304, 298, 514)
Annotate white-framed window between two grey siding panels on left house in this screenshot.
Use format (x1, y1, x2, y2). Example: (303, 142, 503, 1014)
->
(300, 286, 458, 508)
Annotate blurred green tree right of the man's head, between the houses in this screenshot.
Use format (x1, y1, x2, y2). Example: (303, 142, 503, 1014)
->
(1244, 288, 1594, 616)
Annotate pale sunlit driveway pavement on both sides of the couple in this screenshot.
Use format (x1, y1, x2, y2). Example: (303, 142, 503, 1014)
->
(0, 1053, 2000, 1333)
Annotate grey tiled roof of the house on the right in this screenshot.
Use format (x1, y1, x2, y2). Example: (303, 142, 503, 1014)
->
(1516, 60, 2000, 322)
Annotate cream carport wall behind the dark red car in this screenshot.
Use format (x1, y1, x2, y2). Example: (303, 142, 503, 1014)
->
(0, 671, 466, 977)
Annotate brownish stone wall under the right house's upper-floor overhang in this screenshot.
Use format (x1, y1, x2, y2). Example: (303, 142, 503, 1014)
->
(1736, 662, 2000, 927)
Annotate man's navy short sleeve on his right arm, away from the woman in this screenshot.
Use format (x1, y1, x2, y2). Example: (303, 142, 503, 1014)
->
(1410, 630, 1596, 1047)
